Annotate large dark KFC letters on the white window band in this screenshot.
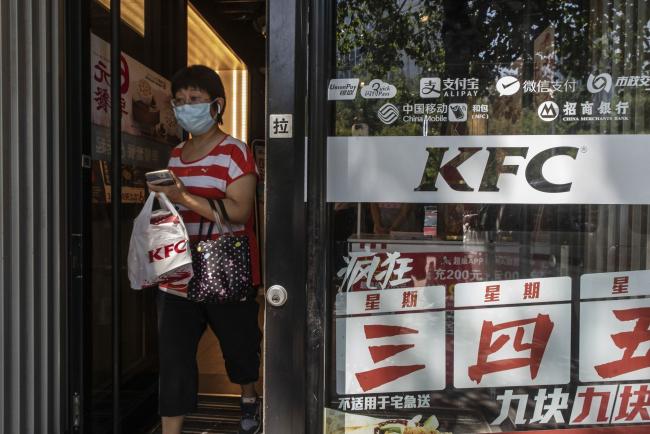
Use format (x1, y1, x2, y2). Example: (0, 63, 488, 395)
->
(414, 146, 579, 193)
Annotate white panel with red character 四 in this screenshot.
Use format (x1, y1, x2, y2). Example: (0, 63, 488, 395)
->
(454, 303, 571, 389)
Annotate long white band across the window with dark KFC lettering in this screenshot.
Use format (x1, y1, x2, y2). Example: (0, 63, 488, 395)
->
(327, 135, 650, 204)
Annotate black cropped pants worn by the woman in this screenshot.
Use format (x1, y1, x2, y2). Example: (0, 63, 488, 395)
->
(157, 291, 262, 416)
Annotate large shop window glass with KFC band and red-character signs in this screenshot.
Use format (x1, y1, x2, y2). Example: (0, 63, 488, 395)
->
(325, 0, 650, 434)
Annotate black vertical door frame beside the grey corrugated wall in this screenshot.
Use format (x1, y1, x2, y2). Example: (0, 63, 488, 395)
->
(62, 0, 92, 433)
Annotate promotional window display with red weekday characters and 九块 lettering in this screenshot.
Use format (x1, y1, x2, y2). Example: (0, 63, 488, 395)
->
(326, 260, 650, 434)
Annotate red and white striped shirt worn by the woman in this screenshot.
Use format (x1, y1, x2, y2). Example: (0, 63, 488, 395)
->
(161, 136, 260, 291)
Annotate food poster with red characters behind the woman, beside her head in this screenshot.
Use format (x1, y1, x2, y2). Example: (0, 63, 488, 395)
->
(90, 34, 182, 202)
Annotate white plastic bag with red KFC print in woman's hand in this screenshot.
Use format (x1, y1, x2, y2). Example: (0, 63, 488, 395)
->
(128, 192, 193, 289)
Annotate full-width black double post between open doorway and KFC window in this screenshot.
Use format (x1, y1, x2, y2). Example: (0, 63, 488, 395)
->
(264, 0, 334, 434)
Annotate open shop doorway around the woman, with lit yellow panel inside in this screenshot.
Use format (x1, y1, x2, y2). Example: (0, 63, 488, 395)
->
(66, 0, 266, 434)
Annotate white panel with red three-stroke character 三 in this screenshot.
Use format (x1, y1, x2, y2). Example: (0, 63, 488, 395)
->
(336, 311, 445, 395)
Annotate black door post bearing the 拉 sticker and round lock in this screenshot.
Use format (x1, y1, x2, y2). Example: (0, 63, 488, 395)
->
(264, 0, 307, 434)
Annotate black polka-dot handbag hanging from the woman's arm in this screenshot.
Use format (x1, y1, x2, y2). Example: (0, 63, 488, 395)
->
(187, 200, 252, 303)
